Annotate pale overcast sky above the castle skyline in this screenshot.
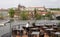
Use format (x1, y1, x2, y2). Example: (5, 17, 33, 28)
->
(0, 0, 60, 8)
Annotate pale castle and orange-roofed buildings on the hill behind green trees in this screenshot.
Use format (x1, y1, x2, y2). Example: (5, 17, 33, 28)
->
(0, 5, 60, 19)
